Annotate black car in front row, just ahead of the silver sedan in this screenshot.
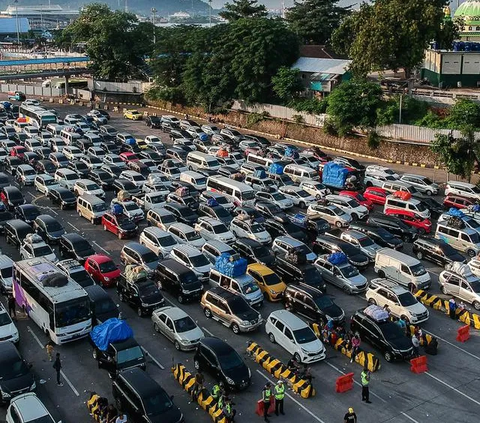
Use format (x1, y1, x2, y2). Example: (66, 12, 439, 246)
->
(193, 337, 252, 390)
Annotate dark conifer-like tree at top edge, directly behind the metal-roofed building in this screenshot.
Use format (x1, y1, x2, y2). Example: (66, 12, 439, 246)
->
(286, 0, 350, 44)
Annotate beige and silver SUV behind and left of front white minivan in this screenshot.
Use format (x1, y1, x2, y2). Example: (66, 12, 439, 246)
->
(200, 286, 263, 335)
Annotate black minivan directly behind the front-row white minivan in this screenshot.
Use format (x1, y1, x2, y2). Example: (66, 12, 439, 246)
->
(283, 283, 345, 327)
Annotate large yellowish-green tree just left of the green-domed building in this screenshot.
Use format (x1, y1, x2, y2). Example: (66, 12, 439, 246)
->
(332, 0, 448, 78)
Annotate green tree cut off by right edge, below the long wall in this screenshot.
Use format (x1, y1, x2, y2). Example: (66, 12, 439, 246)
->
(430, 126, 480, 181)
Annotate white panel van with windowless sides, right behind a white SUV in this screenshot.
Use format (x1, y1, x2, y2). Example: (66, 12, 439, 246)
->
(374, 248, 432, 291)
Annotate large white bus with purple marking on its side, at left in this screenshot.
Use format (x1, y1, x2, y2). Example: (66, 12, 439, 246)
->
(13, 257, 92, 345)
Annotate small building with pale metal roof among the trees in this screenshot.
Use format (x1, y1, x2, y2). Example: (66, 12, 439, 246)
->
(292, 56, 352, 95)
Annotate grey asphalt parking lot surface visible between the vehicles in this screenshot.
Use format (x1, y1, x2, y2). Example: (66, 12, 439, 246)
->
(0, 97, 480, 423)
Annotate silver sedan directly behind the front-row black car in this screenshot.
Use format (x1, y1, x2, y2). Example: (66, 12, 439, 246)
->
(152, 306, 205, 351)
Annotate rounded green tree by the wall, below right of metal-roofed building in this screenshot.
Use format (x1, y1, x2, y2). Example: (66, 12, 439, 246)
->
(327, 80, 383, 136)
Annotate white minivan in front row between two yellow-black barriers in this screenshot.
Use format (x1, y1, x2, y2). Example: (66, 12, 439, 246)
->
(265, 310, 326, 364)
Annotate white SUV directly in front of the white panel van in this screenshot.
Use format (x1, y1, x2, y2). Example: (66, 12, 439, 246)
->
(365, 278, 430, 324)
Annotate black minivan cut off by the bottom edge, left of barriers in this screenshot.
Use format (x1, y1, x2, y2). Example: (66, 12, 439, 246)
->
(112, 369, 184, 423)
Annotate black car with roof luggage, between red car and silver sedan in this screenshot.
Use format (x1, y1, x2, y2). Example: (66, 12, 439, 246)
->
(117, 274, 165, 317)
